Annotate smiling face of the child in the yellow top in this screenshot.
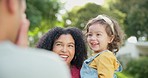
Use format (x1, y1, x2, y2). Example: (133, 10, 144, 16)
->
(87, 23, 111, 53)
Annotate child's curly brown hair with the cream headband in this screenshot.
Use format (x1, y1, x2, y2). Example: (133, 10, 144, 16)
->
(85, 14, 124, 53)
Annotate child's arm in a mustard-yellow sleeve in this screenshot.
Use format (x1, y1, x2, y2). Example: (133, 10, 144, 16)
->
(95, 52, 116, 78)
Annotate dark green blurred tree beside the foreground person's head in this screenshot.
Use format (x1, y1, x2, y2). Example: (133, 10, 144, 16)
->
(26, 0, 61, 30)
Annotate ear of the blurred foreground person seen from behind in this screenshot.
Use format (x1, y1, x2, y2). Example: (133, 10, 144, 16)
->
(5, 0, 16, 13)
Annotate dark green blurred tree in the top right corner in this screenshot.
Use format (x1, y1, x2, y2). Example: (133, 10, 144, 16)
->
(110, 0, 148, 38)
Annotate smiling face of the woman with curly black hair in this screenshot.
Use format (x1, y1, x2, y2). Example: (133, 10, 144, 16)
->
(52, 34, 75, 66)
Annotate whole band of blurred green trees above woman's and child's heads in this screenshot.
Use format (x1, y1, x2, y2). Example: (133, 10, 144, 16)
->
(26, 0, 148, 45)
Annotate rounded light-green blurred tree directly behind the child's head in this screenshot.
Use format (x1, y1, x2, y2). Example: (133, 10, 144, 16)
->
(63, 3, 125, 29)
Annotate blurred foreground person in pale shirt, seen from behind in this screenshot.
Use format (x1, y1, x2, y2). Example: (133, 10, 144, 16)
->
(0, 0, 70, 78)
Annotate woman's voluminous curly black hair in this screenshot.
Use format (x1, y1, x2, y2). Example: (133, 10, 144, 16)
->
(36, 27, 87, 68)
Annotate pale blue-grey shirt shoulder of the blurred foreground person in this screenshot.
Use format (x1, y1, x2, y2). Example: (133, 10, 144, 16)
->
(0, 41, 70, 78)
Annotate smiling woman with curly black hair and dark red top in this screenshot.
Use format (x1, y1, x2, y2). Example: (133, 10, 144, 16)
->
(37, 27, 87, 78)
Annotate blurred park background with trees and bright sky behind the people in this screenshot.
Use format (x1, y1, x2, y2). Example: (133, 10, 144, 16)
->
(26, 0, 148, 78)
